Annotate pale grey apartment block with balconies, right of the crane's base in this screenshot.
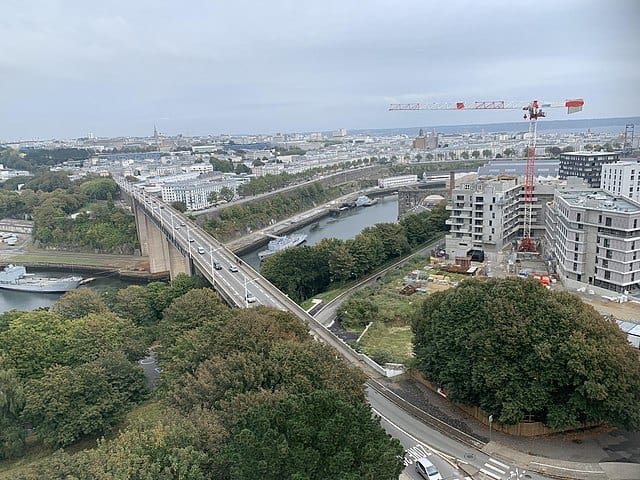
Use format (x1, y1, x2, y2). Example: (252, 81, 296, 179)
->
(545, 189, 640, 294)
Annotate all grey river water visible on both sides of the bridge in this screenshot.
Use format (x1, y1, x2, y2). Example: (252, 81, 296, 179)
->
(0, 196, 398, 313)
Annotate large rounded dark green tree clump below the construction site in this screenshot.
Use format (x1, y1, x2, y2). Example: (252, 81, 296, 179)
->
(413, 278, 640, 430)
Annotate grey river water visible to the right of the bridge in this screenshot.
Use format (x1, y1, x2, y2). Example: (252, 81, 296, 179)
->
(242, 195, 398, 270)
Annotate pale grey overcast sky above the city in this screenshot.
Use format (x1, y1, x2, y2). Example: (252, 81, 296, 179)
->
(0, 0, 640, 141)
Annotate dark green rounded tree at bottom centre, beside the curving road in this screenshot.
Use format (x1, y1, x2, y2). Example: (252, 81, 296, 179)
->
(224, 390, 404, 480)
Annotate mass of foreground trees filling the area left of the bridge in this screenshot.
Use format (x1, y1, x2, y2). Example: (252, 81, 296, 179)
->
(0, 275, 403, 480)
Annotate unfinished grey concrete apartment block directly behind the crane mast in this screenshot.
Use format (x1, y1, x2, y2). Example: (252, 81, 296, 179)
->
(445, 176, 556, 261)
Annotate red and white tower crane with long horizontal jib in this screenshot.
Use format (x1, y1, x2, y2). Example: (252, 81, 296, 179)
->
(389, 98, 584, 252)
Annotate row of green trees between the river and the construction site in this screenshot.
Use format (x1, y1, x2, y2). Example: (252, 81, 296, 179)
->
(260, 205, 448, 302)
